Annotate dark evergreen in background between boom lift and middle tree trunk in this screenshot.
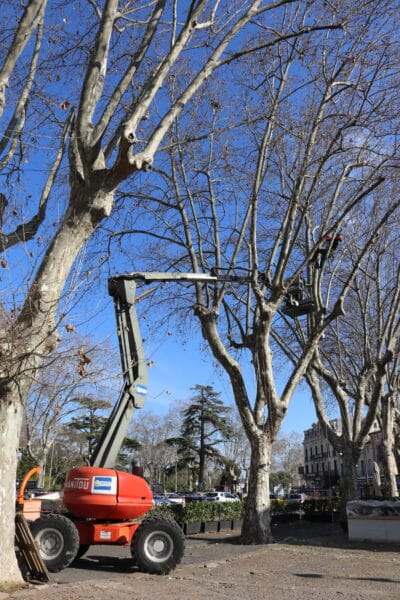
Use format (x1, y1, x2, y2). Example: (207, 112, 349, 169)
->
(178, 384, 233, 488)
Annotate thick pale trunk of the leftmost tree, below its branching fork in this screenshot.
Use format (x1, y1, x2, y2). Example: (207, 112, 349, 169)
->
(0, 182, 113, 584)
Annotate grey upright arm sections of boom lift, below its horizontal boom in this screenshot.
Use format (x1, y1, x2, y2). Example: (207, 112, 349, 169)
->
(90, 277, 147, 468)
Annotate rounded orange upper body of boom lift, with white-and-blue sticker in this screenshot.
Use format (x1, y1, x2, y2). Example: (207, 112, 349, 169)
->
(63, 467, 154, 521)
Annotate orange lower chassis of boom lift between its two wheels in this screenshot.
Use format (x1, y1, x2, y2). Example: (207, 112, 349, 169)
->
(75, 521, 140, 546)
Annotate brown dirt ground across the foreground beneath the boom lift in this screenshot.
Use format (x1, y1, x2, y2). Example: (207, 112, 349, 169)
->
(0, 521, 400, 600)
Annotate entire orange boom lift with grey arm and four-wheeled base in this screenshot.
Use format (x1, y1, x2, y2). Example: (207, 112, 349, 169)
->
(30, 272, 316, 573)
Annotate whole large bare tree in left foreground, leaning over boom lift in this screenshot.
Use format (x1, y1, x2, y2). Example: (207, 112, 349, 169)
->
(0, 0, 316, 582)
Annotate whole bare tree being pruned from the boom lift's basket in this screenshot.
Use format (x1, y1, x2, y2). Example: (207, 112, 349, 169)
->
(116, 4, 399, 543)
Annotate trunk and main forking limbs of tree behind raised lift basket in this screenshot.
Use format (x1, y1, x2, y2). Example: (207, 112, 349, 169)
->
(195, 304, 318, 544)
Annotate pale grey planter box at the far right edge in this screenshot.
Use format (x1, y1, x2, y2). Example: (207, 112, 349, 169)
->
(346, 500, 400, 543)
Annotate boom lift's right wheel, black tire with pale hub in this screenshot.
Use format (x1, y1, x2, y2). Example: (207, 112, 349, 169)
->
(131, 515, 185, 575)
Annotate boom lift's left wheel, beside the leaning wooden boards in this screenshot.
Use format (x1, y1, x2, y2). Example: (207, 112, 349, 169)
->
(31, 514, 79, 573)
